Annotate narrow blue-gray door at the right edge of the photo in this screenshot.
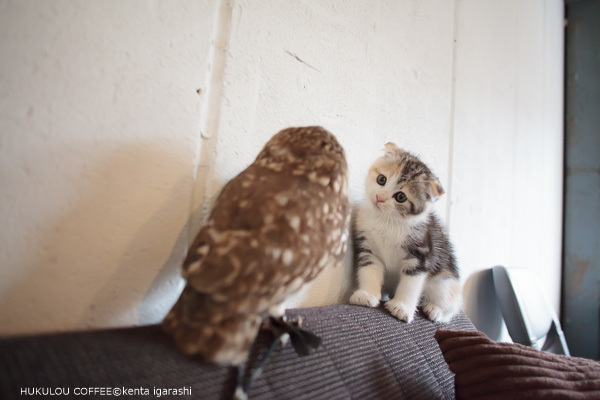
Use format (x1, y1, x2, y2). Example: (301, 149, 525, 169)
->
(561, 0, 600, 360)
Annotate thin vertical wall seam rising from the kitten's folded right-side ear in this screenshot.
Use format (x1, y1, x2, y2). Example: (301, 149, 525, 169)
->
(446, 0, 460, 230)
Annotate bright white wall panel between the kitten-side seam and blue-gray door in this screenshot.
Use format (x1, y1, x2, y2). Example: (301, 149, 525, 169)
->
(449, 0, 564, 336)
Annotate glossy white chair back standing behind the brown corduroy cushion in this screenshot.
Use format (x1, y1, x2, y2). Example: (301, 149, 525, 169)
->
(492, 266, 570, 356)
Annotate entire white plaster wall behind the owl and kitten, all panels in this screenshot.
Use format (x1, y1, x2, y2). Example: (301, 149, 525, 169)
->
(0, 0, 562, 334)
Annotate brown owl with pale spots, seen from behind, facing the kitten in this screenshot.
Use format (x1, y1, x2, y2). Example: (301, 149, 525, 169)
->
(163, 126, 350, 365)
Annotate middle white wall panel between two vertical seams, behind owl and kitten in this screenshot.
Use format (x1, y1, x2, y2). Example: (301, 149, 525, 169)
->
(198, 0, 454, 306)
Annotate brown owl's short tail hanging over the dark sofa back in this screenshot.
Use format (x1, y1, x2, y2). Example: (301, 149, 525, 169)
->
(162, 285, 261, 365)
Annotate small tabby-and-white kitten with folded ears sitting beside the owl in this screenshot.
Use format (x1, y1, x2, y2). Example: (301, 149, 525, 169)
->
(350, 143, 462, 322)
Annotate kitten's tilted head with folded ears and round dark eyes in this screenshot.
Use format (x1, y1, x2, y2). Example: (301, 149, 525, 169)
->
(366, 143, 444, 218)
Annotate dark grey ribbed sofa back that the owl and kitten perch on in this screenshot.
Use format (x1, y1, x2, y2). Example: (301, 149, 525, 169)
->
(0, 305, 474, 400)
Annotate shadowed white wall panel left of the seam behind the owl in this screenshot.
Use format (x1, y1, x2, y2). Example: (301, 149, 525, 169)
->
(0, 0, 215, 334)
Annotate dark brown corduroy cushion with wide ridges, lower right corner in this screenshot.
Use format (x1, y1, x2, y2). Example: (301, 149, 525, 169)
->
(435, 330, 600, 400)
